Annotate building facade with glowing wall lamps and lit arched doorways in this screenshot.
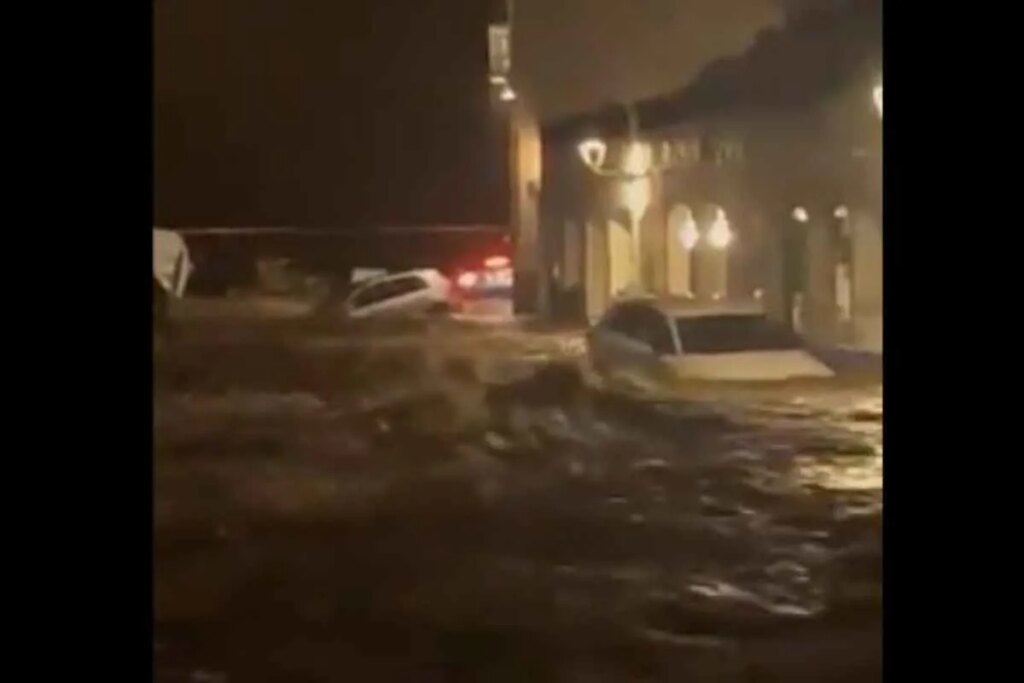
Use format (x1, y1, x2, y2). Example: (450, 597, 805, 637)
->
(541, 0, 882, 349)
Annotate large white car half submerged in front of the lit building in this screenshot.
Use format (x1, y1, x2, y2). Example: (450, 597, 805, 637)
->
(587, 297, 834, 383)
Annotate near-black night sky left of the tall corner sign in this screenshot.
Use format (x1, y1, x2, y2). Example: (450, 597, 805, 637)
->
(154, 0, 510, 229)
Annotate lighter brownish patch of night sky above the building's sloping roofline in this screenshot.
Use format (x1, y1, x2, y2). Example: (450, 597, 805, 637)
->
(516, 0, 774, 119)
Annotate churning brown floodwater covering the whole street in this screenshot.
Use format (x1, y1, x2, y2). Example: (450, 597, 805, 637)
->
(154, 321, 883, 683)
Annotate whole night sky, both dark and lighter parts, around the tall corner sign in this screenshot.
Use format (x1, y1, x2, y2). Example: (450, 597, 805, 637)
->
(154, 0, 782, 227)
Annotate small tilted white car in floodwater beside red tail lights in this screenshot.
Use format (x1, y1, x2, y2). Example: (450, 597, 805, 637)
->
(345, 268, 452, 318)
